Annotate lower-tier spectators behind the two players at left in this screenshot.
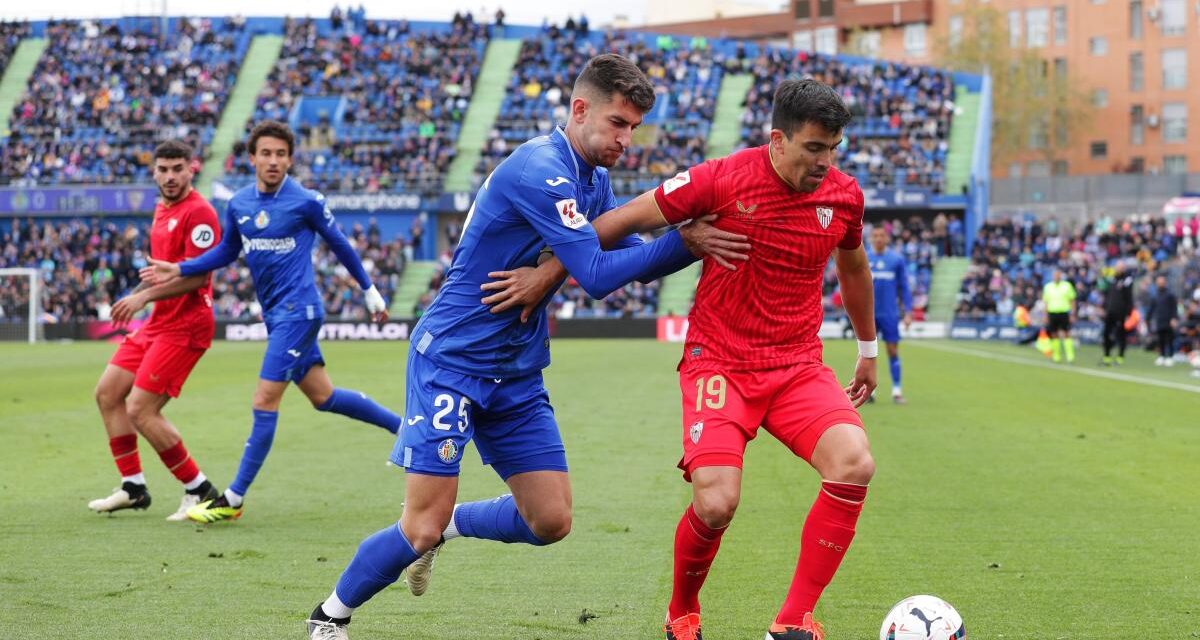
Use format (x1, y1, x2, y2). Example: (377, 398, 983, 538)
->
(0, 219, 410, 323)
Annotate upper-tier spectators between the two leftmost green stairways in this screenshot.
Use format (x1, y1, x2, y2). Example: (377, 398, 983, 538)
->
(0, 18, 250, 186)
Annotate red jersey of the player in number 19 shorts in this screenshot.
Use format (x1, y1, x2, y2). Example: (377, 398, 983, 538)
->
(654, 145, 863, 370)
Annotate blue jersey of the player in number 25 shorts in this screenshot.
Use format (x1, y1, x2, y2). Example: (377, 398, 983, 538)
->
(413, 130, 696, 378)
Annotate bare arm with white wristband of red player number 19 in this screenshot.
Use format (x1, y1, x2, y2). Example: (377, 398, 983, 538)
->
(834, 241, 878, 407)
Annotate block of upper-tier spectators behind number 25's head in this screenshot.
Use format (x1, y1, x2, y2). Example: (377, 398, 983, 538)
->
(476, 23, 725, 196)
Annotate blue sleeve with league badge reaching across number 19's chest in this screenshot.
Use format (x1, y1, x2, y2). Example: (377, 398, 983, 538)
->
(509, 168, 688, 299)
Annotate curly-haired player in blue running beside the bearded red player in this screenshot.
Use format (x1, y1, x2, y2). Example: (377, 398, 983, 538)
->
(142, 120, 402, 522)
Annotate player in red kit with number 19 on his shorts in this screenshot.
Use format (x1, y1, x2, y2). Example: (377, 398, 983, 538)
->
(485, 79, 878, 640)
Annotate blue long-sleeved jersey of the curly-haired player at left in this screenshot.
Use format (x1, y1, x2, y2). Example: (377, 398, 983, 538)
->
(179, 177, 371, 321)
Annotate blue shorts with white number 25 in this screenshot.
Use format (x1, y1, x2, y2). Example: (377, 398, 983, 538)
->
(390, 349, 566, 480)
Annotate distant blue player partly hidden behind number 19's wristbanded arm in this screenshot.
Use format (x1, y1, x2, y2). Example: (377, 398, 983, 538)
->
(868, 226, 912, 405)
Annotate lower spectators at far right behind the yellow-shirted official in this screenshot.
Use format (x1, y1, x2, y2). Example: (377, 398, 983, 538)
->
(956, 216, 1200, 365)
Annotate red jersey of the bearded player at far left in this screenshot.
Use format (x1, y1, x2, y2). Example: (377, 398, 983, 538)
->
(142, 189, 221, 349)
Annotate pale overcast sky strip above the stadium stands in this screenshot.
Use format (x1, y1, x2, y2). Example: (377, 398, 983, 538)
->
(0, 0, 662, 26)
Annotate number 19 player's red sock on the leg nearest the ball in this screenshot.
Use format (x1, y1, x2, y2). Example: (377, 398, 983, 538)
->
(772, 480, 866, 626)
